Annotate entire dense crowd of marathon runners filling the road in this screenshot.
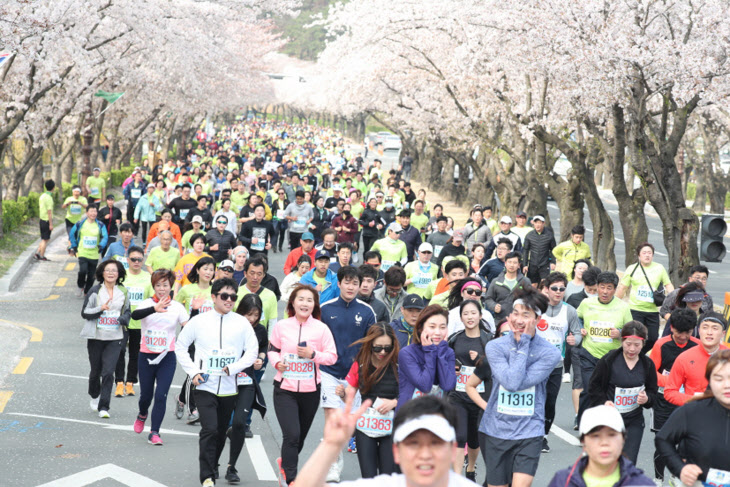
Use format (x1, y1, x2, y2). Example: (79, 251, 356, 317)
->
(38, 120, 730, 487)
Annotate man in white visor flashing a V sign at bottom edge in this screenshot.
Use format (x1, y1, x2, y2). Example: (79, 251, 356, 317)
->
(296, 390, 477, 487)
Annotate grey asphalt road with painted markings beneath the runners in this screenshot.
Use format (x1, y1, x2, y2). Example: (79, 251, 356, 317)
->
(0, 150, 728, 487)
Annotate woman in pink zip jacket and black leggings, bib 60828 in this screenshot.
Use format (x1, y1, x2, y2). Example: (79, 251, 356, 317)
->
(268, 284, 337, 485)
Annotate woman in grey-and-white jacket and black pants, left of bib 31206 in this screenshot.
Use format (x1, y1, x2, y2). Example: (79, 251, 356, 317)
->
(81, 260, 130, 419)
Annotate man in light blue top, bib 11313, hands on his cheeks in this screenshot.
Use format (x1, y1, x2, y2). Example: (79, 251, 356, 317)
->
(479, 286, 561, 487)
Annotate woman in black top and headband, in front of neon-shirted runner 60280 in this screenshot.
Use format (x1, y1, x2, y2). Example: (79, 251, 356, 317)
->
(587, 321, 657, 464)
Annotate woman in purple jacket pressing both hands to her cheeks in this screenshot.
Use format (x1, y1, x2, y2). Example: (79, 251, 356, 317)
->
(398, 305, 456, 409)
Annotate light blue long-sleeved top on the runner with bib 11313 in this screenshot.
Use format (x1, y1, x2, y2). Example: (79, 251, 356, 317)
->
(479, 333, 562, 440)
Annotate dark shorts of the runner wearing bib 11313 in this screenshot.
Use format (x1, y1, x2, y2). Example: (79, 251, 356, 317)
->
(479, 432, 543, 485)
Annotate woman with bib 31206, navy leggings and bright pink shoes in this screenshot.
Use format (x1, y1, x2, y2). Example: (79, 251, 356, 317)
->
(132, 269, 188, 446)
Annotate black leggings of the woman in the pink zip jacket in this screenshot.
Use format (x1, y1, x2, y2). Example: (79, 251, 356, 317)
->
(274, 381, 320, 484)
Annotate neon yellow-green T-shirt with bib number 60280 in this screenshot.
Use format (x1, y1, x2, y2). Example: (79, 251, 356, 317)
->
(578, 296, 633, 358)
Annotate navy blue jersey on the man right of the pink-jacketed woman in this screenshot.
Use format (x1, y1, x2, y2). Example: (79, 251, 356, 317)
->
(319, 296, 376, 379)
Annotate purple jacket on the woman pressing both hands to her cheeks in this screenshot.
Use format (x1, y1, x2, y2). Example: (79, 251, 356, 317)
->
(396, 340, 456, 411)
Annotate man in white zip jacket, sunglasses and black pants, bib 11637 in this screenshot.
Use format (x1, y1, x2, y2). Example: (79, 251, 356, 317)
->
(175, 278, 258, 487)
